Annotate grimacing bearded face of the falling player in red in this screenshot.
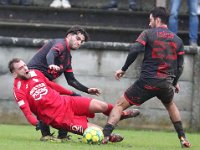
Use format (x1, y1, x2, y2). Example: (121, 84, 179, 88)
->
(13, 60, 31, 80)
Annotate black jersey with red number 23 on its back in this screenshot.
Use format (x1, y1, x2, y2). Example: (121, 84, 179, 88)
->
(136, 27, 184, 80)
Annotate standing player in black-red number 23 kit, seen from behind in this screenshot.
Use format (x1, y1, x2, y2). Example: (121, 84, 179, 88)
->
(103, 7, 191, 148)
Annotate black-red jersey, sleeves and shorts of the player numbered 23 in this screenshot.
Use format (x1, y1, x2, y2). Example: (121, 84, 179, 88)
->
(122, 26, 184, 105)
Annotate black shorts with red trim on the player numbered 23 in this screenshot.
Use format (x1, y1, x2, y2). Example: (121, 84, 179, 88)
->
(124, 80, 174, 105)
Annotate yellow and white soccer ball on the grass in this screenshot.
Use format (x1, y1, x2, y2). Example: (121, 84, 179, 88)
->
(83, 127, 104, 144)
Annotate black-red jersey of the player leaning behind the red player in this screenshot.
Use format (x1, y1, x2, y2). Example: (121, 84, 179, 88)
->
(28, 39, 73, 80)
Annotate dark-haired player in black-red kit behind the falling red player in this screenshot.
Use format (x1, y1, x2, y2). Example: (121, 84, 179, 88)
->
(28, 26, 100, 141)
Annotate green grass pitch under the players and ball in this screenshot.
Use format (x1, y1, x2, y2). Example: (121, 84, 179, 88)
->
(0, 125, 200, 150)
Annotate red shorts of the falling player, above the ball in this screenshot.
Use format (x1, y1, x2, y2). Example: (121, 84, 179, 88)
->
(50, 96, 94, 135)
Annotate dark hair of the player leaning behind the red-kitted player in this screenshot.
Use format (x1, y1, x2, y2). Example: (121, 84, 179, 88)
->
(66, 25, 89, 42)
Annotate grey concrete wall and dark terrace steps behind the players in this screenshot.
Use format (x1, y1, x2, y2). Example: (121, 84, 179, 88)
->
(0, 0, 200, 131)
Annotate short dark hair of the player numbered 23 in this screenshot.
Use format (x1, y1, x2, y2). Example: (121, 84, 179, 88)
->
(150, 7, 169, 24)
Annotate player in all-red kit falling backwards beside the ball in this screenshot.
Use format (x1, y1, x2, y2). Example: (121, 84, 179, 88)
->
(8, 58, 138, 142)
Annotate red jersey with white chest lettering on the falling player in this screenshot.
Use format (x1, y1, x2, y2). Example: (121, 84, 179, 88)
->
(14, 70, 73, 125)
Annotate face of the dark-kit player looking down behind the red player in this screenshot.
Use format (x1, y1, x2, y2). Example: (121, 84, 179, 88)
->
(68, 33, 85, 50)
